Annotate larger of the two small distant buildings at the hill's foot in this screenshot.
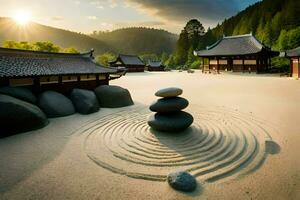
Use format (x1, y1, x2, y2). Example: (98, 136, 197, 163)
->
(109, 54, 146, 72)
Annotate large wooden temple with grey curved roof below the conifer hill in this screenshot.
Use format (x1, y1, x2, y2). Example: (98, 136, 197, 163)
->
(195, 33, 279, 73)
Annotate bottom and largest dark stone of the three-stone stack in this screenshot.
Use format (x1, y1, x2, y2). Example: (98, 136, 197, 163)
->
(148, 111, 194, 132)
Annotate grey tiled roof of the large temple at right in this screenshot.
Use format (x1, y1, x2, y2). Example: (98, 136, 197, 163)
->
(195, 34, 271, 56)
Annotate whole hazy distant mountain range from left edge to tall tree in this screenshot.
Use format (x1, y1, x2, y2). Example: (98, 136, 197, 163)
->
(0, 17, 178, 55)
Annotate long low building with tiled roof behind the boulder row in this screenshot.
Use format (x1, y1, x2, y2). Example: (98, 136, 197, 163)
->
(0, 48, 117, 92)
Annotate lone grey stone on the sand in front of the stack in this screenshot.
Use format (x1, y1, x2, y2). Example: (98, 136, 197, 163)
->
(167, 171, 197, 192)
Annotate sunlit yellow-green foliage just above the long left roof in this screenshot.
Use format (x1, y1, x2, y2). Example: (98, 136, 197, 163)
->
(2, 41, 78, 53)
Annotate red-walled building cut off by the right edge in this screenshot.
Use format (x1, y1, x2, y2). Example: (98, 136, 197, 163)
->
(286, 47, 300, 78)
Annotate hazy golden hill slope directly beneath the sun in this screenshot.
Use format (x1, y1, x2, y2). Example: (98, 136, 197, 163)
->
(0, 18, 113, 54)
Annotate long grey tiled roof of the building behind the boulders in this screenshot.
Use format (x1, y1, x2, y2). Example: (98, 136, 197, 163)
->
(0, 48, 116, 77)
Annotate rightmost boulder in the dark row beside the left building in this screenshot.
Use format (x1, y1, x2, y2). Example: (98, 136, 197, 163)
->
(95, 85, 133, 108)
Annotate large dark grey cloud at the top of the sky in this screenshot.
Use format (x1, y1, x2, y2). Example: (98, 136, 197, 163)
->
(127, 0, 258, 27)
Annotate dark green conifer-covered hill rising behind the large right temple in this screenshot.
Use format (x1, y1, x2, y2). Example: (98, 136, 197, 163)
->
(198, 0, 300, 49)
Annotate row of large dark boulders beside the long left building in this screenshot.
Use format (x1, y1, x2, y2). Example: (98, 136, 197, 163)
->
(0, 85, 133, 138)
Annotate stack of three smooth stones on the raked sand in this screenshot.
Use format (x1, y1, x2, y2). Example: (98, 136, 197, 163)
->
(148, 87, 194, 132)
